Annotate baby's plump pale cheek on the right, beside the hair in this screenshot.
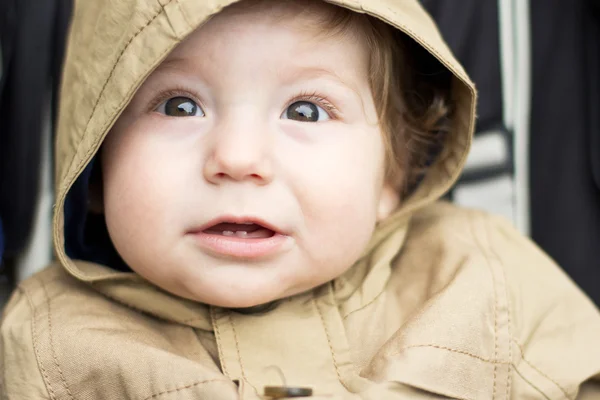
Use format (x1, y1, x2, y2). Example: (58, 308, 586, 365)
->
(288, 128, 384, 256)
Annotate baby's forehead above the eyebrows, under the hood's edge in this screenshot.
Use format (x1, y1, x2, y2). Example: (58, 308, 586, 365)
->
(165, 0, 369, 76)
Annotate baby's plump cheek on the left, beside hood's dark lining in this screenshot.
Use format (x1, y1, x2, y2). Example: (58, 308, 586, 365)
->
(102, 123, 193, 256)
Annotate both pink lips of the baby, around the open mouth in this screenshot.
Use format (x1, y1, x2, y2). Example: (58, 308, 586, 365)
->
(187, 216, 291, 260)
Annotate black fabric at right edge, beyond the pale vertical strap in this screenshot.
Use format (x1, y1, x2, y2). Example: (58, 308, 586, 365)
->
(530, 0, 600, 305)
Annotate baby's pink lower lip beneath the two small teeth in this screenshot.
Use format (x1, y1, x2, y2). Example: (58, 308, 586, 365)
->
(190, 232, 290, 260)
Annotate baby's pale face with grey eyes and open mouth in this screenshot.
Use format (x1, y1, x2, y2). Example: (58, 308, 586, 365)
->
(102, 2, 397, 307)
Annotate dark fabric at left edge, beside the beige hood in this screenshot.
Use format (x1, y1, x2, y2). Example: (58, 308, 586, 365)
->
(0, 0, 72, 266)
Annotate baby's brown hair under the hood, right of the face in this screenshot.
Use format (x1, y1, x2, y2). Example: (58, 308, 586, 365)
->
(316, 7, 451, 195)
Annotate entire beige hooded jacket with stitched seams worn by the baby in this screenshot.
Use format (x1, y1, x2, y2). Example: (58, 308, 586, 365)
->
(0, 0, 600, 400)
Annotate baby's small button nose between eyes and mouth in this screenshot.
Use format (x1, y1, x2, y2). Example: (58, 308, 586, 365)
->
(203, 118, 273, 185)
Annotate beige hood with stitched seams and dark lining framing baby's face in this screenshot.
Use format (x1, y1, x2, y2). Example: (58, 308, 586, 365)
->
(53, 0, 475, 328)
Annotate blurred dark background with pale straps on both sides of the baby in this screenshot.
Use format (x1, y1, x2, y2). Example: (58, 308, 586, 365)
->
(0, 0, 600, 306)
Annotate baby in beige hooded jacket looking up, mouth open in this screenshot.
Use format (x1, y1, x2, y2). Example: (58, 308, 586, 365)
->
(0, 0, 600, 400)
